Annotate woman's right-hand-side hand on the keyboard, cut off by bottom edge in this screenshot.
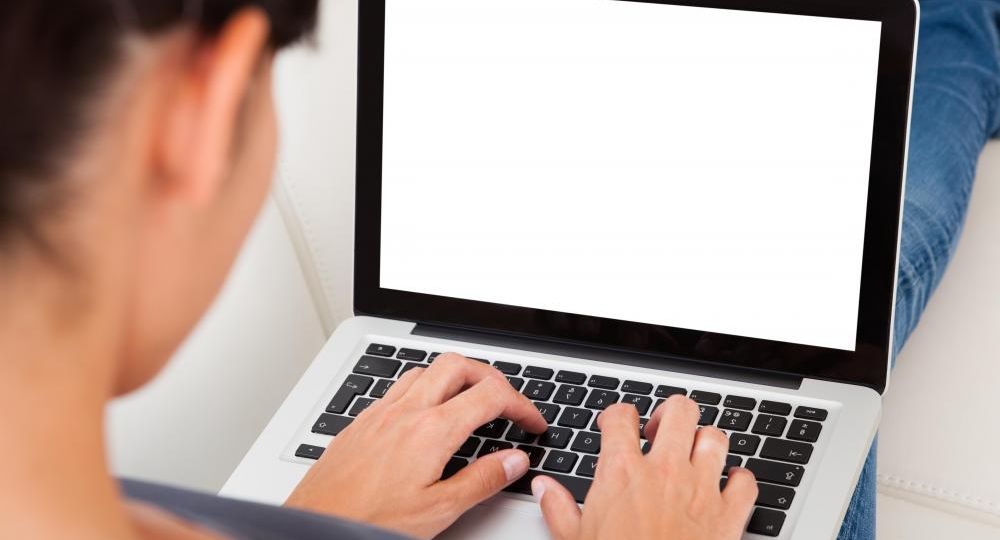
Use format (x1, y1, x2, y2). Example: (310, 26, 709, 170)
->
(531, 396, 757, 540)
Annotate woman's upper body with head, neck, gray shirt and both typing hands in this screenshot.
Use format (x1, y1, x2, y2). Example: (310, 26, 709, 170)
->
(0, 0, 756, 539)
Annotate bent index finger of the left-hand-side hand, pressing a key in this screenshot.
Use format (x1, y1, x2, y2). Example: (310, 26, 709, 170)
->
(437, 377, 548, 440)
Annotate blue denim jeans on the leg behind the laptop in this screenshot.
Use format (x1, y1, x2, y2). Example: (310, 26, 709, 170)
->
(840, 0, 1000, 540)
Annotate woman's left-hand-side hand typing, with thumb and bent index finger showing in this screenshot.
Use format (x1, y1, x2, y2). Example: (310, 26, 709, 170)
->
(286, 354, 547, 538)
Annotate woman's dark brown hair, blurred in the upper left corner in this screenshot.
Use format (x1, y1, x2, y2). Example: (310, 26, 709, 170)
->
(0, 0, 318, 253)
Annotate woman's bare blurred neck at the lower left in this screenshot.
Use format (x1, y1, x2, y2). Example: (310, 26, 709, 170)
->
(0, 254, 132, 539)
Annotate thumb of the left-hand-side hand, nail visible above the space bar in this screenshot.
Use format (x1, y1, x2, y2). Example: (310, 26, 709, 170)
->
(438, 450, 528, 514)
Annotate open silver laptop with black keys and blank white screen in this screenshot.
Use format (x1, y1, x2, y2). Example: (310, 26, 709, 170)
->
(222, 0, 917, 539)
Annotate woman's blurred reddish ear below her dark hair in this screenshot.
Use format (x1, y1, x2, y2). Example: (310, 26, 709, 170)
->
(157, 8, 270, 206)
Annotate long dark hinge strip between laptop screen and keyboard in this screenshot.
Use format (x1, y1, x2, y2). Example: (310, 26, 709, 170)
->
(412, 324, 802, 390)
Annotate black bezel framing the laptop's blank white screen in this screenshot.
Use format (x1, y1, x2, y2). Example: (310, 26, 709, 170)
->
(354, 0, 917, 393)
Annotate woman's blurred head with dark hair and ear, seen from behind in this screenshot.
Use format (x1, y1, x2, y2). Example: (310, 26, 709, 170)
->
(0, 0, 318, 390)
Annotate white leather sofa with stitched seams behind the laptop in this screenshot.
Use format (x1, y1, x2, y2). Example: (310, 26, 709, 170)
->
(108, 0, 1000, 539)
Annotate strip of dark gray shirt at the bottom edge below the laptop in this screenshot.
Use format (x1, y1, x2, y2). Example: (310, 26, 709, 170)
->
(121, 480, 407, 540)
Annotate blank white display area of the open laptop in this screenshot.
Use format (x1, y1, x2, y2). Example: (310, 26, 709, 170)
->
(380, 0, 881, 350)
